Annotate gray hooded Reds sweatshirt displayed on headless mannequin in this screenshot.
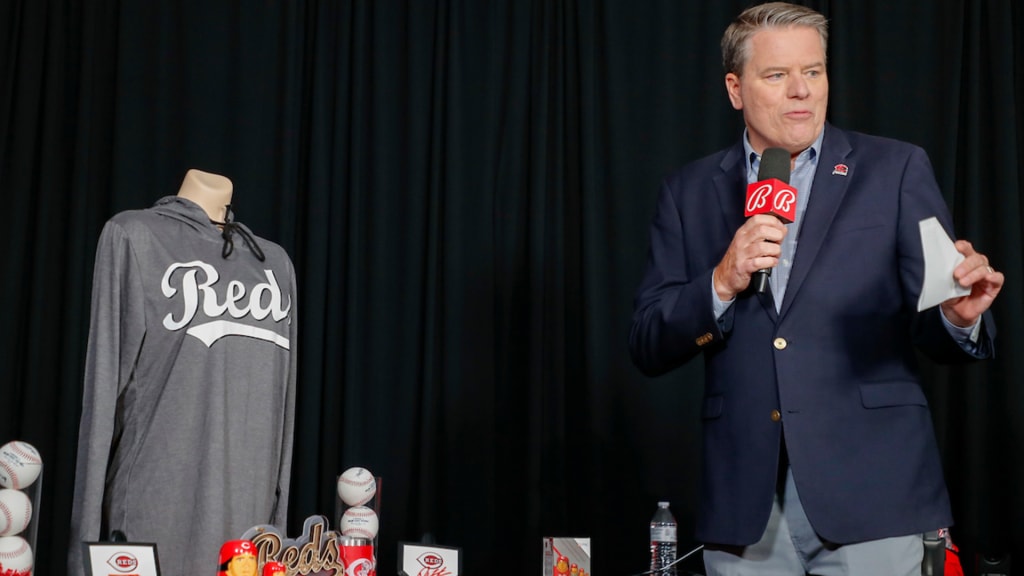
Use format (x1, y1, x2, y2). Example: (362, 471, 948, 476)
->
(69, 196, 297, 576)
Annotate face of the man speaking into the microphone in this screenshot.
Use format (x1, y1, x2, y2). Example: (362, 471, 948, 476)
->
(725, 26, 828, 154)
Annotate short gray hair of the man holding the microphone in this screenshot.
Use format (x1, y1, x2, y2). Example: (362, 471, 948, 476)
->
(722, 2, 828, 76)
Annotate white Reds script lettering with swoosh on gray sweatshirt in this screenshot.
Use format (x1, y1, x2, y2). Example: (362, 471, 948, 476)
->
(160, 260, 292, 348)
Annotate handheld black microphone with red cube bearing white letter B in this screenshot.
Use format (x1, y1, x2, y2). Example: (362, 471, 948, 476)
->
(743, 148, 797, 293)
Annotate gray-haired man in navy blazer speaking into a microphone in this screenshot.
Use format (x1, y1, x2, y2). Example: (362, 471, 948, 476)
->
(630, 3, 1004, 576)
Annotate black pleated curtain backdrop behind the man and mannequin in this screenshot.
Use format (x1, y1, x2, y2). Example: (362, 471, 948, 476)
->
(0, 0, 1024, 576)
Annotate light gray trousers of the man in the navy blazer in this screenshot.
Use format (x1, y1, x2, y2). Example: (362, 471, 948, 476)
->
(703, 469, 924, 576)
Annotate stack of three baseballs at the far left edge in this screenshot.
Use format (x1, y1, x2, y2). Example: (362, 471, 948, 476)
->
(0, 440, 43, 576)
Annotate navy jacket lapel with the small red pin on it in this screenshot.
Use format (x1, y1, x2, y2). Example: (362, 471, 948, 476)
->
(779, 124, 856, 316)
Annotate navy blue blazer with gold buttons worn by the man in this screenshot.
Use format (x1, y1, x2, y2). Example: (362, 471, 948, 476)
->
(630, 125, 994, 545)
